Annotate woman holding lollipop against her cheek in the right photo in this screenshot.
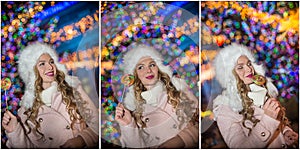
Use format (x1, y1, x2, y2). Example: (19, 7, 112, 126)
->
(213, 43, 298, 148)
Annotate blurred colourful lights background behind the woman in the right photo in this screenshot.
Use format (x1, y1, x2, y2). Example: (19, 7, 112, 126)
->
(201, 1, 299, 148)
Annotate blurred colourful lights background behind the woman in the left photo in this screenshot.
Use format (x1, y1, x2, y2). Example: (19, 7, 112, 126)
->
(1, 1, 100, 148)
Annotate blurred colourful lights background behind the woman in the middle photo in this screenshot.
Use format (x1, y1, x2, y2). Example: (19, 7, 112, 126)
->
(101, 2, 199, 148)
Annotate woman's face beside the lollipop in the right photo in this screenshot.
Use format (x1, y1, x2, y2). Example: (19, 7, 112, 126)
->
(234, 55, 254, 84)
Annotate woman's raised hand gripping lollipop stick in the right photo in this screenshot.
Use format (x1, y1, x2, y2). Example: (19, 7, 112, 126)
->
(263, 98, 280, 119)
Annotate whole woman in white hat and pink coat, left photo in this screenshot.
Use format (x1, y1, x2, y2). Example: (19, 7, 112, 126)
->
(2, 43, 99, 148)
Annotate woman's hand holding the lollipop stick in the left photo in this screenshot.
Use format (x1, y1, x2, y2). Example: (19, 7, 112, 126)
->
(2, 110, 18, 133)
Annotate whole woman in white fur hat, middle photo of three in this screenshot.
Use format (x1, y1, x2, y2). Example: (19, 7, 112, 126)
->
(115, 45, 199, 148)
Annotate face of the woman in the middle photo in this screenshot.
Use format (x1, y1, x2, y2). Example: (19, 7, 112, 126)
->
(135, 57, 158, 90)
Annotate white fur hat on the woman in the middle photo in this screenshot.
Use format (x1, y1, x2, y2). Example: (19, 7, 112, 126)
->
(123, 45, 173, 77)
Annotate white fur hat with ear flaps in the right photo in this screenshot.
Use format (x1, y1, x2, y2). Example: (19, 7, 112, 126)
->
(213, 43, 278, 111)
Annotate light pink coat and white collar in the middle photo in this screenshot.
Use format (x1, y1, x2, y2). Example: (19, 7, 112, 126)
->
(120, 80, 199, 148)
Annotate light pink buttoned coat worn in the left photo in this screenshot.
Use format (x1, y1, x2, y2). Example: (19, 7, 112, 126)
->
(7, 79, 99, 148)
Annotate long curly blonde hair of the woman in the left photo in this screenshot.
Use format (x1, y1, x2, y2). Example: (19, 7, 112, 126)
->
(24, 66, 91, 138)
